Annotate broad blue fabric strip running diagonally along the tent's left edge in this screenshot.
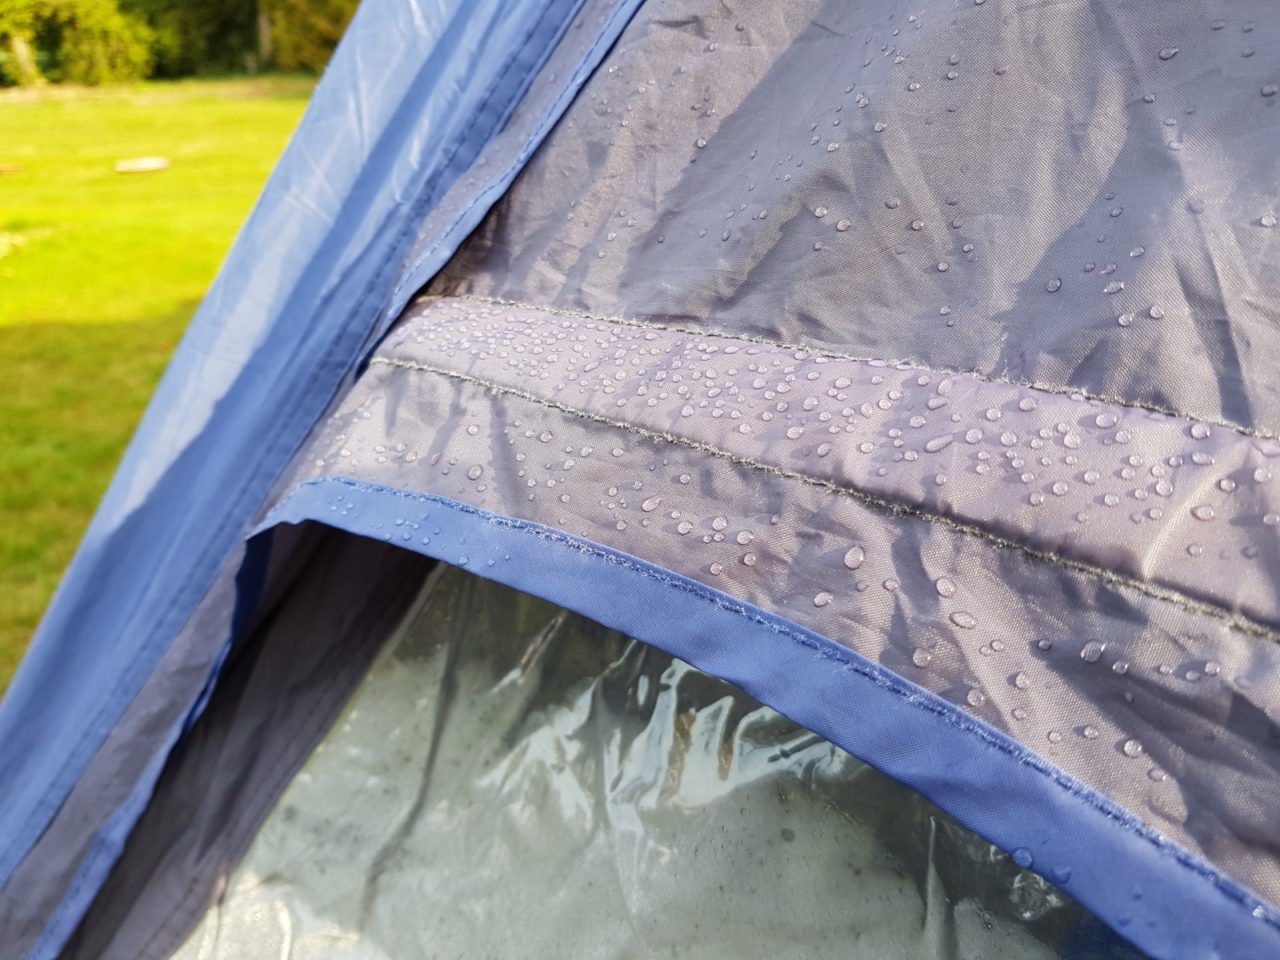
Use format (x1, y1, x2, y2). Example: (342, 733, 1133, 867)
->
(0, 0, 636, 947)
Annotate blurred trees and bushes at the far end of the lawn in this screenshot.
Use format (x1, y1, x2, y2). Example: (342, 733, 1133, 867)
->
(0, 0, 358, 86)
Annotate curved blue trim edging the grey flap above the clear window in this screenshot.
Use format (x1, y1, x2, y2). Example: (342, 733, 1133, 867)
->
(260, 477, 1280, 960)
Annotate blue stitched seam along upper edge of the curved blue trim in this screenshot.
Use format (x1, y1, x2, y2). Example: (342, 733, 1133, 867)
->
(270, 476, 1280, 931)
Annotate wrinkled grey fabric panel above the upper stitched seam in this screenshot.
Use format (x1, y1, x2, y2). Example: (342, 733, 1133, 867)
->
(433, 0, 1280, 435)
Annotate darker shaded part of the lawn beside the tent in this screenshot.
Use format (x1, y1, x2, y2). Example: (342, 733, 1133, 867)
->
(0, 301, 198, 691)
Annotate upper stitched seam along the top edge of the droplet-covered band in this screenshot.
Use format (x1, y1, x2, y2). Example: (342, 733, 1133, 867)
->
(445, 293, 1280, 440)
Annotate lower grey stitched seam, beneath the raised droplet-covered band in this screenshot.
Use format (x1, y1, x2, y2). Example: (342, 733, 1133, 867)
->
(370, 356, 1280, 641)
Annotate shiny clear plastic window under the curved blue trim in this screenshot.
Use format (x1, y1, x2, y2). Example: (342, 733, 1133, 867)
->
(175, 567, 1139, 960)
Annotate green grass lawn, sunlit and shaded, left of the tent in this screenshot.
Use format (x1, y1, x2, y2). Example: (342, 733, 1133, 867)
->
(0, 77, 314, 690)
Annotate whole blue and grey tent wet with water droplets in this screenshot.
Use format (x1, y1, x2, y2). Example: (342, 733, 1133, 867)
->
(0, 0, 1280, 960)
